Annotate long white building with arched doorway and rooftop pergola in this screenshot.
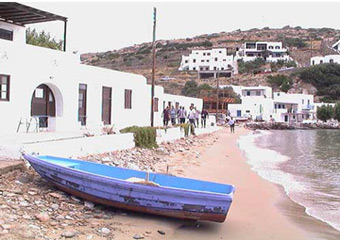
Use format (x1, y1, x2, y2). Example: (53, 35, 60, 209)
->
(0, 3, 202, 134)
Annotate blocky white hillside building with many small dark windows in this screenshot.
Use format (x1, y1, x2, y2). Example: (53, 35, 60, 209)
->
(178, 48, 237, 77)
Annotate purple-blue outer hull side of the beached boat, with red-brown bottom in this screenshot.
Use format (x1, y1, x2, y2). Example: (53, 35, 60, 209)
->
(24, 155, 232, 222)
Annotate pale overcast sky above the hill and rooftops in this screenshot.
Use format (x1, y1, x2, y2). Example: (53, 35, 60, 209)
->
(24, 2, 340, 53)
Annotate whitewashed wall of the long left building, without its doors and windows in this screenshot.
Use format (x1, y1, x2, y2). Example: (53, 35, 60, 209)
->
(0, 24, 202, 135)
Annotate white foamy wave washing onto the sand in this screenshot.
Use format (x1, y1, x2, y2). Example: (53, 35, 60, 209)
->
(238, 131, 340, 231)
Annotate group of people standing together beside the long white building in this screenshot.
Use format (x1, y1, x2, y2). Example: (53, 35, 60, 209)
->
(162, 106, 209, 128)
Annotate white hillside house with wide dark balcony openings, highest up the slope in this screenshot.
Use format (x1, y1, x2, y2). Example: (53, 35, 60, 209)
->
(235, 42, 292, 62)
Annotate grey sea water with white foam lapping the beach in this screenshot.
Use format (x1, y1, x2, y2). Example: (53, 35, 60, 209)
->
(238, 130, 340, 231)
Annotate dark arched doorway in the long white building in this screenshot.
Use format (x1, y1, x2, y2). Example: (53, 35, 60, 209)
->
(31, 84, 56, 128)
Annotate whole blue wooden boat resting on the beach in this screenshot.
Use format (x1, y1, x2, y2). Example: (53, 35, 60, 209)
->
(23, 154, 235, 222)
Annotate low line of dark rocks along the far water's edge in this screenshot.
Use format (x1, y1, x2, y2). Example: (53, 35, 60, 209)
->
(244, 122, 340, 130)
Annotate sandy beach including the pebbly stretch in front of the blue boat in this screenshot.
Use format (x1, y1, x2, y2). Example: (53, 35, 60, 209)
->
(0, 127, 340, 240)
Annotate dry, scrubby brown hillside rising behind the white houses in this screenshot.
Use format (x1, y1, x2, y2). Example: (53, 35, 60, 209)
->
(81, 26, 340, 94)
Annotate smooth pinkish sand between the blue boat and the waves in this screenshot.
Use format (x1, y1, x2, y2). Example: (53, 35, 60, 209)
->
(110, 128, 339, 240)
